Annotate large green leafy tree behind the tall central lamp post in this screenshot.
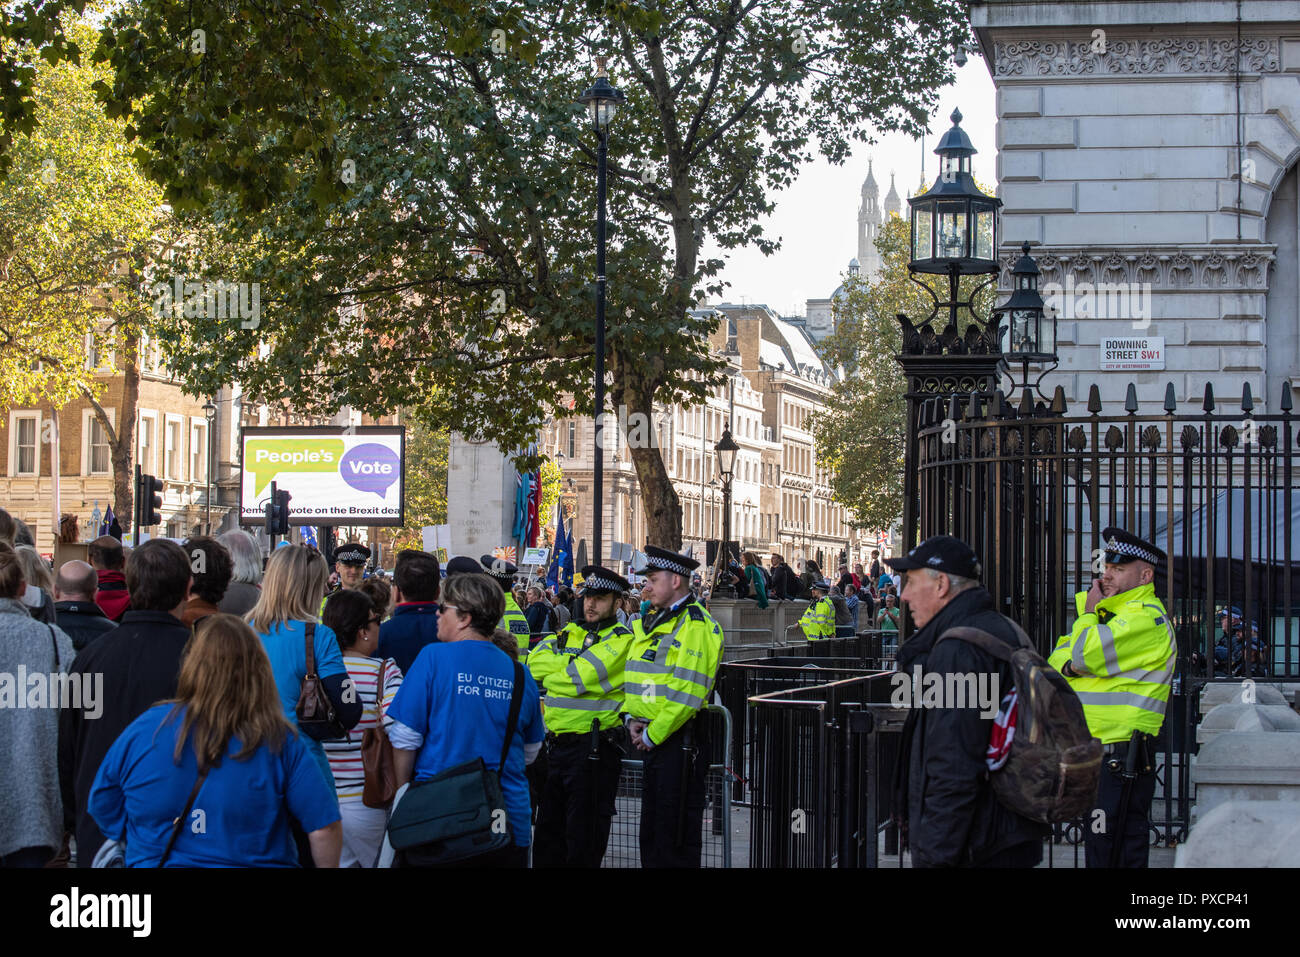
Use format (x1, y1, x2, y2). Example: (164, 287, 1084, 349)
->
(98, 0, 969, 545)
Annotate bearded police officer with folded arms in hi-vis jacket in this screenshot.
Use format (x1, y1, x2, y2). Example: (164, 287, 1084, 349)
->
(528, 564, 632, 867)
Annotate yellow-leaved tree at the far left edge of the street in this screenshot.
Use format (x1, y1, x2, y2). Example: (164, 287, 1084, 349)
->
(0, 14, 172, 527)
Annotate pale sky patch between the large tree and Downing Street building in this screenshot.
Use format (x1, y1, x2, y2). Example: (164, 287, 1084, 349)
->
(709, 55, 997, 316)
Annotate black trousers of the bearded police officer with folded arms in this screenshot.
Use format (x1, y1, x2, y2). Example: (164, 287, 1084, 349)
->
(533, 735, 623, 867)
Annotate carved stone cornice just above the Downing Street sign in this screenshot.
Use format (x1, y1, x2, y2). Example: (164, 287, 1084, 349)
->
(998, 246, 1277, 293)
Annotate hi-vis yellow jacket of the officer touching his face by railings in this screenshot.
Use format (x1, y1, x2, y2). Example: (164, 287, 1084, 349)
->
(1048, 585, 1178, 744)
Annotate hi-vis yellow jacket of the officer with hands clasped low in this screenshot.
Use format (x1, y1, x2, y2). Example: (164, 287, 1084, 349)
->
(623, 599, 723, 745)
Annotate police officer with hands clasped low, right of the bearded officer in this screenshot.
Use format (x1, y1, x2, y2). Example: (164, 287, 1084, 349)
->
(623, 545, 723, 867)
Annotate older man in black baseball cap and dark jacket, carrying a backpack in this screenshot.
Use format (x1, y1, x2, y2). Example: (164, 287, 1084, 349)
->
(885, 534, 1048, 867)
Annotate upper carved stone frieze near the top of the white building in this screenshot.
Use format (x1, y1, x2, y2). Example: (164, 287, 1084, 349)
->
(993, 31, 1282, 79)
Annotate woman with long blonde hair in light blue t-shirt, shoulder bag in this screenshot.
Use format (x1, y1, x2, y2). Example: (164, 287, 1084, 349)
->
(244, 545, 363, 788)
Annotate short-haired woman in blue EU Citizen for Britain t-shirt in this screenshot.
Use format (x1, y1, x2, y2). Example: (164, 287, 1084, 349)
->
(389, 572, 546, 867)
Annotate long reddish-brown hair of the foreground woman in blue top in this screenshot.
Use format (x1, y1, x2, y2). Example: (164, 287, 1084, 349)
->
(165, 614, 295, 770)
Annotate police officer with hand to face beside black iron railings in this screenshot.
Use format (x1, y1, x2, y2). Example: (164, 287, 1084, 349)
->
(1048, 528, 1178, 867)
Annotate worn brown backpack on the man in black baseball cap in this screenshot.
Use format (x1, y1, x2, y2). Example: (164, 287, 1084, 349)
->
(935, 622, 1101, 824)
